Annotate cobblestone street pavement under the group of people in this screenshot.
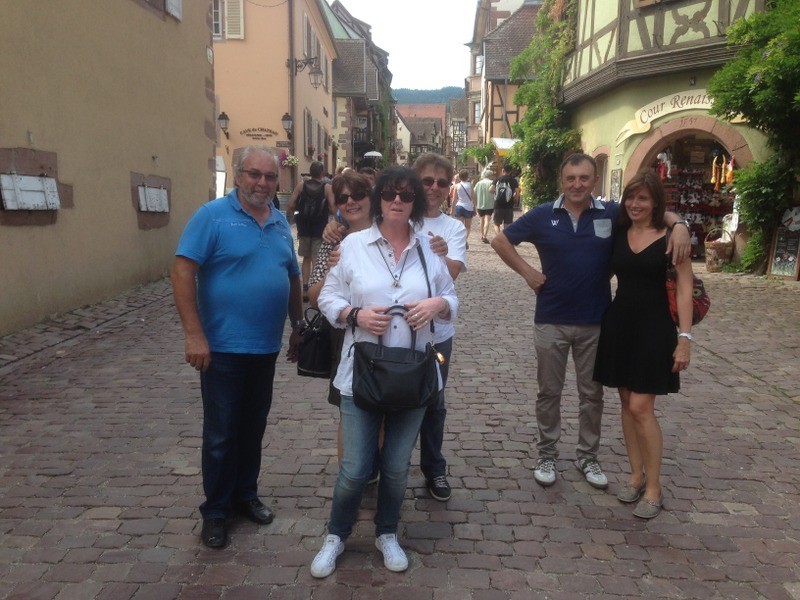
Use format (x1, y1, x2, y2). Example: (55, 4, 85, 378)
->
(0, 240, 800, 600)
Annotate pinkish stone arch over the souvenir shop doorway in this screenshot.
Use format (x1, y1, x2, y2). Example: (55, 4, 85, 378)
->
(623, 115, 753, 185)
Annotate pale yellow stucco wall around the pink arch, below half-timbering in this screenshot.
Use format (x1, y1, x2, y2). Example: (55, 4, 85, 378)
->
(571, 71, 769, 191)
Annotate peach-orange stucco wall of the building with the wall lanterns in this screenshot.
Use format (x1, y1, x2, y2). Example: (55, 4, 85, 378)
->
(214, 0, 336, 192)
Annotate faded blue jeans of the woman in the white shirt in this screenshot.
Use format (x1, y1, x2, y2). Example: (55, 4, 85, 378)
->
(328, 395, 425, 540)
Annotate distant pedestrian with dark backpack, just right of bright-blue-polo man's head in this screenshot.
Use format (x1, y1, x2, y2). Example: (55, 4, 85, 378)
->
(286, 161, 336, 300)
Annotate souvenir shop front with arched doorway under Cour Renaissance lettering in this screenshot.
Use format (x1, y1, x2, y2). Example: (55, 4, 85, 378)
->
(572, 73, 768, 257)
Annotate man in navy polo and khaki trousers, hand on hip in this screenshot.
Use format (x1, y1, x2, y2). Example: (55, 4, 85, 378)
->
(492, 154, 691, 488)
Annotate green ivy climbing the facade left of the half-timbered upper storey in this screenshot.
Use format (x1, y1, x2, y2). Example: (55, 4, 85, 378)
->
(510, 0, 580, 205)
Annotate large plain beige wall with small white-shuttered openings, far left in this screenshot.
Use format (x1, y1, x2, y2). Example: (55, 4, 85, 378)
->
(0, 0, 214, 334)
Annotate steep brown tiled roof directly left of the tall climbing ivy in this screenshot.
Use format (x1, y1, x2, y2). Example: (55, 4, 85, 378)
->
(483, 2, 542, 80)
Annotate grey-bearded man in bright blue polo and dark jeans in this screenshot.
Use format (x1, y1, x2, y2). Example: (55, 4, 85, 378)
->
(171, 146, 303, 548)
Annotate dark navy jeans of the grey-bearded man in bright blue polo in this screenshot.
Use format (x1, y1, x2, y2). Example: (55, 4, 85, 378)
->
(200, 352, 278, 519)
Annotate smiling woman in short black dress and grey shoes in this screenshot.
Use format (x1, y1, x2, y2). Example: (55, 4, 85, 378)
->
(594, 171, 692, 519)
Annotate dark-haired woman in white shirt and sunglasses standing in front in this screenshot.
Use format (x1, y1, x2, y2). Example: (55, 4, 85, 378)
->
(311, 167, 458, 577)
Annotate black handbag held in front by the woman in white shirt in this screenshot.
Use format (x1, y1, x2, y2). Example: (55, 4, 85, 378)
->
(353, 305, 439, 412)
